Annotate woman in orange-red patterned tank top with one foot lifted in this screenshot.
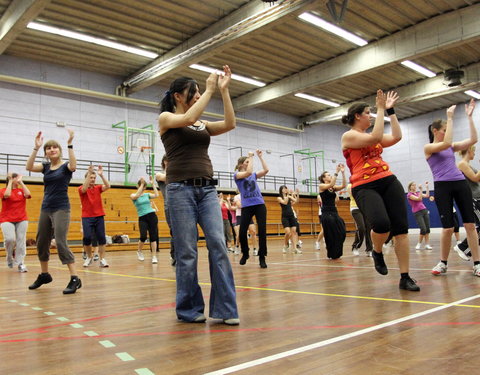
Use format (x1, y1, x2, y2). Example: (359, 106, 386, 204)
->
(342, 90, 420, 291)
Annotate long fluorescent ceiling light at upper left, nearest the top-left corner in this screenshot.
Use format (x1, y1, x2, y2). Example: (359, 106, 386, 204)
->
(27, 22, 158, 59)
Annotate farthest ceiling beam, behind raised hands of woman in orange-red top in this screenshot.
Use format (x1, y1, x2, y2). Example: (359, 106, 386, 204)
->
(301, 63, 480, 125)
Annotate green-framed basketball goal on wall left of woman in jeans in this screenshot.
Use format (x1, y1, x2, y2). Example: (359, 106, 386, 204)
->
(112, 121, 157, 186)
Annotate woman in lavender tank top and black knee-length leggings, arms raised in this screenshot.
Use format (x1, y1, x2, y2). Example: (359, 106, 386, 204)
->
(423, 99, 480, 276)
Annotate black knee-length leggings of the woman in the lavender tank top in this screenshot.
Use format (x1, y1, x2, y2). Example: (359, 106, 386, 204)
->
(434, 180, 475, 228)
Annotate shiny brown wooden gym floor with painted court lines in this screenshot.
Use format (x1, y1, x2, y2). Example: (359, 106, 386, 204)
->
(0, 234, 480, 375)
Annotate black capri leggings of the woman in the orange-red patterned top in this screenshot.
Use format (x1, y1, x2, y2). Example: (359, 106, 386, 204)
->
(352, 175, 408, 236)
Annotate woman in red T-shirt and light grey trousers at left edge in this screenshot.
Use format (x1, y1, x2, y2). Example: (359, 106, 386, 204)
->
(0, 173, 31, 272)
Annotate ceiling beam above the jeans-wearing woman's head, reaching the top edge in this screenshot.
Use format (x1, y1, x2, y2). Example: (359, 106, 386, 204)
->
(124, 0, 318, 93)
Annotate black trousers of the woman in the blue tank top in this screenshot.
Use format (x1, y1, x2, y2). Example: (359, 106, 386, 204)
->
(238, 204, 267, 256)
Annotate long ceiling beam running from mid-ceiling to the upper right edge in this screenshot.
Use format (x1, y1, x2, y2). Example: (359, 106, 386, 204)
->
(233, 4, 480, 110)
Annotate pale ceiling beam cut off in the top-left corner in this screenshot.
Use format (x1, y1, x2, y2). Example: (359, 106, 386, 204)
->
(0, 0, 51, 54)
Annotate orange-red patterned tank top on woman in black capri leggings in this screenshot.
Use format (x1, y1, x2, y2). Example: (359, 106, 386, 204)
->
(343, 143, 393, 187)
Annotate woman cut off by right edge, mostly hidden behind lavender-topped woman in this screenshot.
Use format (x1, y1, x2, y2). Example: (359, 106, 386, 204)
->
(453, 146, 480, 260)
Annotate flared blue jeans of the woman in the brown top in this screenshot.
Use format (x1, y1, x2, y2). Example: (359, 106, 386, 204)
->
(167, 182, 238, 322)
